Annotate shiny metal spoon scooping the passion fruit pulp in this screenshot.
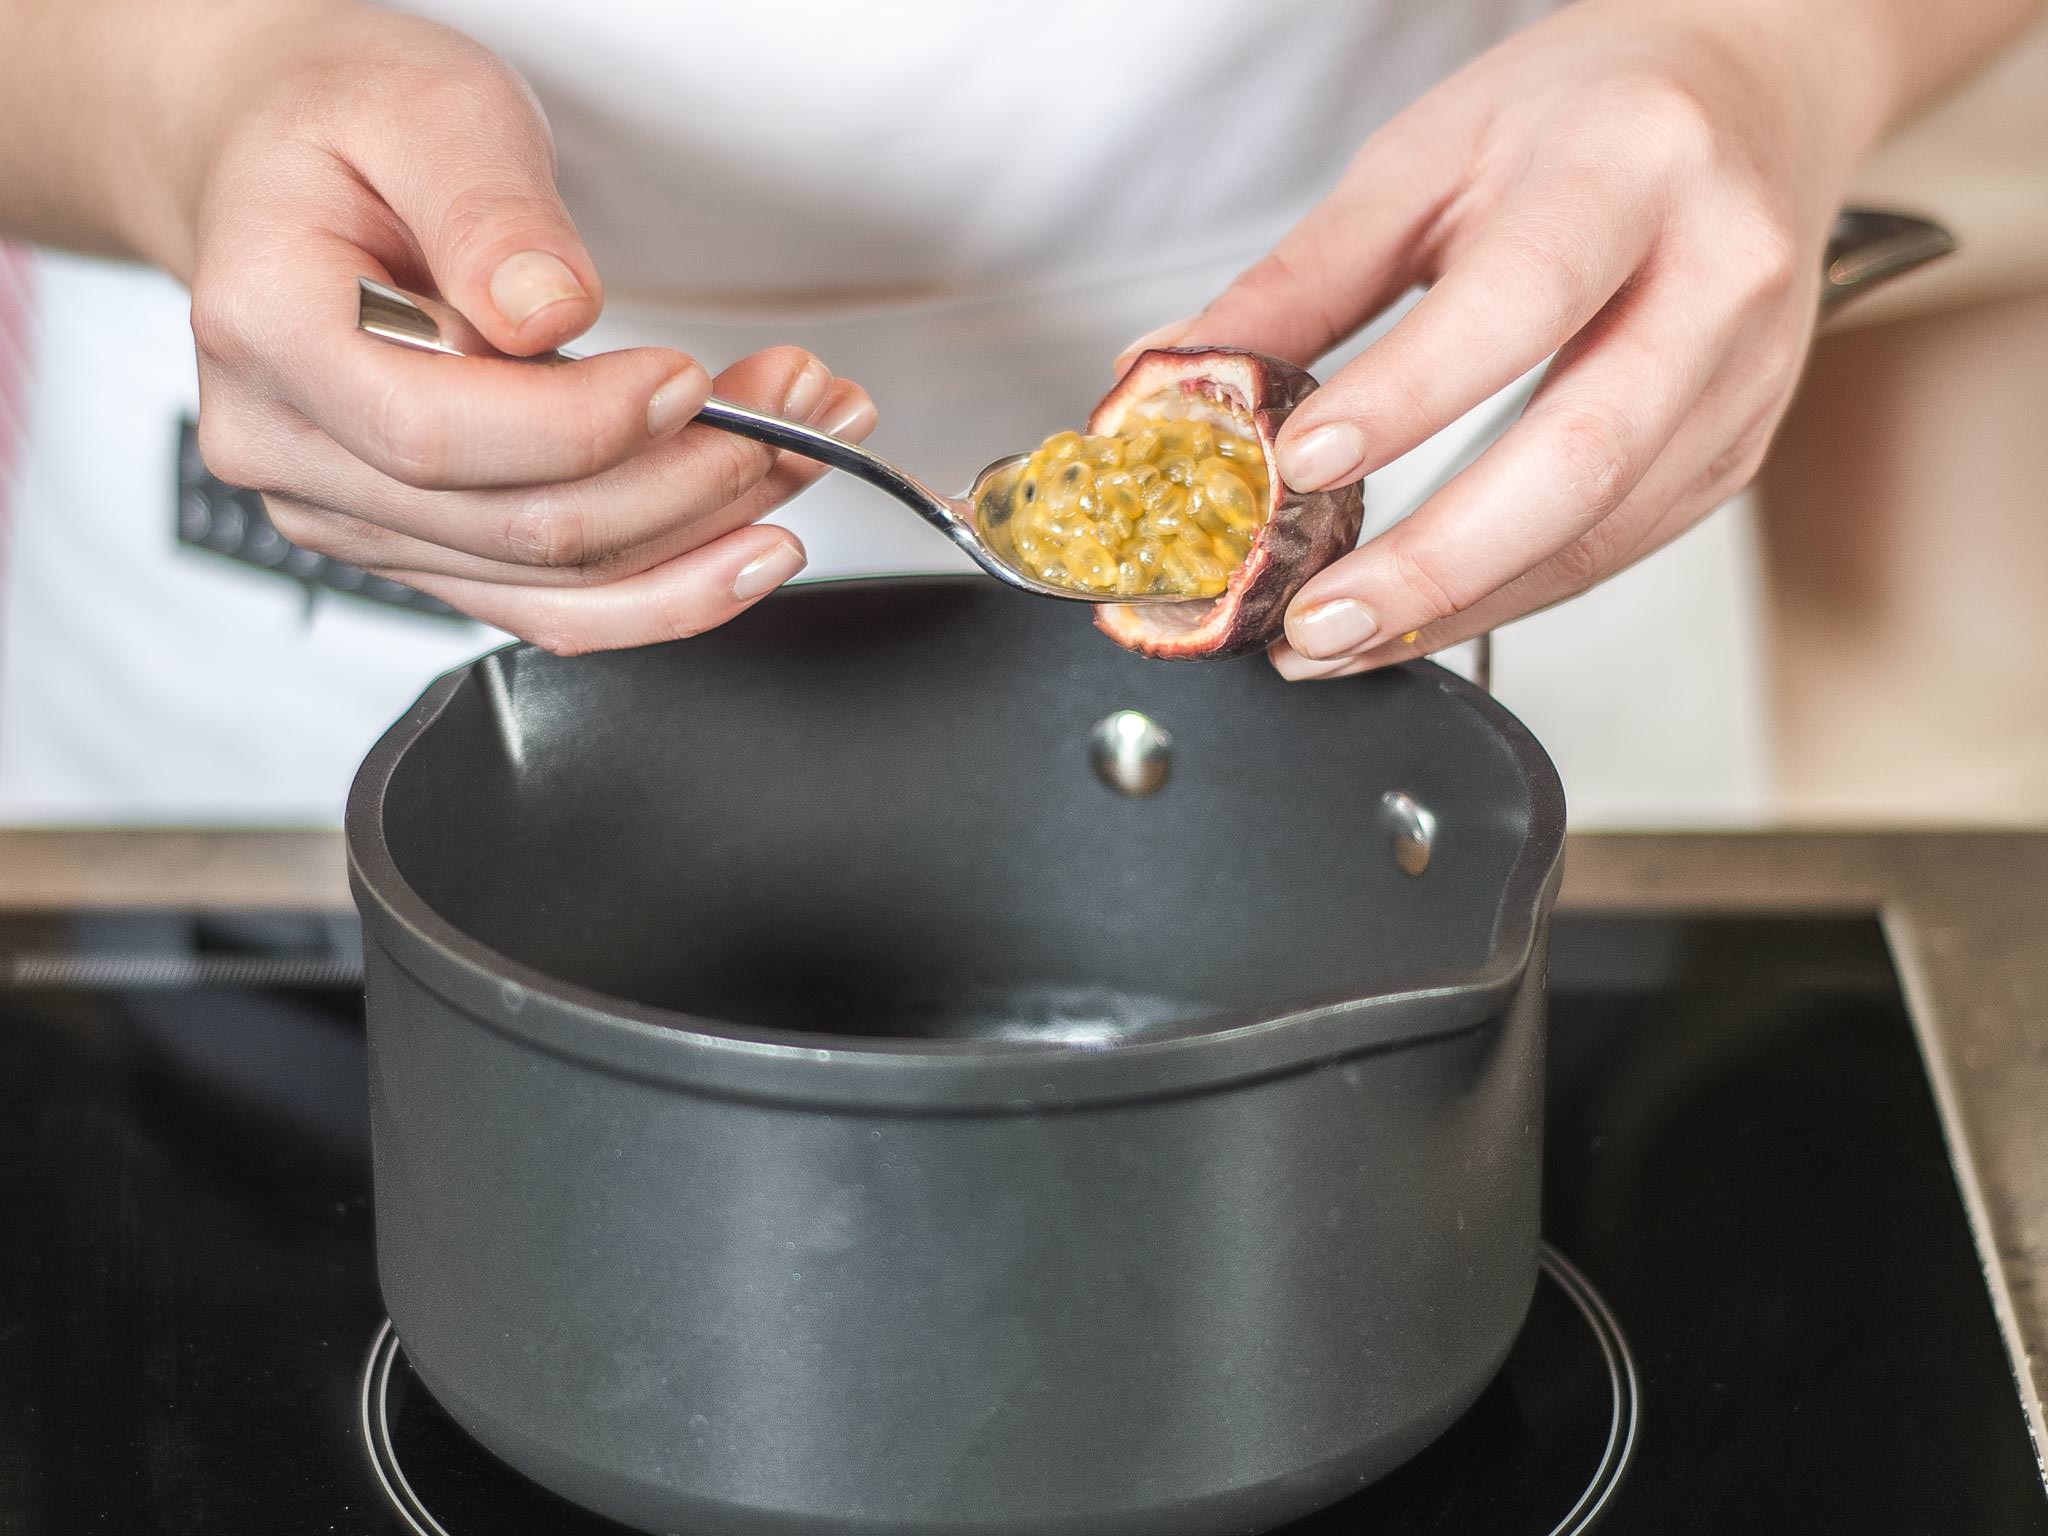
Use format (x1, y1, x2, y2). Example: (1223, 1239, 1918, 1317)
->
(356, 276, 1188, 602)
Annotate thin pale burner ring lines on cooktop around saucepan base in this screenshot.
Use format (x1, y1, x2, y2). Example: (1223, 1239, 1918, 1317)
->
(360, 1243, 1642, 1536)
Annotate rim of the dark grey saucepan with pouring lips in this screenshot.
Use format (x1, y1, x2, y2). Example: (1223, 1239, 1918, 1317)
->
(344, 575, 1565, 1112)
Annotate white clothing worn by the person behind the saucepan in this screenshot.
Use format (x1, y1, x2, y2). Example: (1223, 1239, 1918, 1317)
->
(0, 0, 1757, 823)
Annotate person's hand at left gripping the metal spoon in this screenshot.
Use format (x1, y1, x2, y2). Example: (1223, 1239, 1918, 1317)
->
(188, 6, 874, 653)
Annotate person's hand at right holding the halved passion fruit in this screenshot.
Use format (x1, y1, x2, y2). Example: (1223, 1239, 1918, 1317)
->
(1124, 0, 1880, 678)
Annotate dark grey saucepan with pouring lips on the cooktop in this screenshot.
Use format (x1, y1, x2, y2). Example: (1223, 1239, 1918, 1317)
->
(348, 580, 1565, 1536)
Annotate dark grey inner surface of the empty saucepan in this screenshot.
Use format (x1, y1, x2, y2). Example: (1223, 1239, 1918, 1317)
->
(368, 582, 1561, 1042)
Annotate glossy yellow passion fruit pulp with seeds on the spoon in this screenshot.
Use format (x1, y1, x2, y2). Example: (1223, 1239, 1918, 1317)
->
(985, 391, 1270, 598)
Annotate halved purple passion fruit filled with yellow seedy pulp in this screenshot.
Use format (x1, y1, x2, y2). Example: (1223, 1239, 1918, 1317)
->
(985, 346, 1364, 662)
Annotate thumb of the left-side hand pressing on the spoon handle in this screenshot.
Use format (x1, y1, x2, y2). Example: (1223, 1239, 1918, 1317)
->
(362, 49, 602, 356)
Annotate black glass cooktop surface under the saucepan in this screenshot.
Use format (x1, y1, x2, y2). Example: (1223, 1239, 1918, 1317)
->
(0, 918, 2048, 1536)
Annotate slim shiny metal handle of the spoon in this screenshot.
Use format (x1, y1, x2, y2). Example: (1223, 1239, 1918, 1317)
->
(356, 276, 987, 548)
